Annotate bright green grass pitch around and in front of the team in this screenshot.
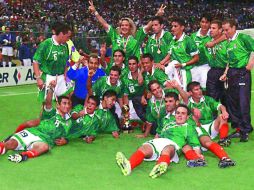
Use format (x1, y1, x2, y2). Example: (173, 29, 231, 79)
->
(0, 73, 254, 190)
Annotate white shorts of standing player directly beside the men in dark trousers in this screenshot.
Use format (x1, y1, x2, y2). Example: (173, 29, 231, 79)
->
(191, 64, 210, 88)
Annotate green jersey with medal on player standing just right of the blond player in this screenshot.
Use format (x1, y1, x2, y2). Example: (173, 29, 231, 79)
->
(144, 30, 173, 63)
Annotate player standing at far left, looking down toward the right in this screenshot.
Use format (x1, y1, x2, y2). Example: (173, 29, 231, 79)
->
(33, 22, 71, 102)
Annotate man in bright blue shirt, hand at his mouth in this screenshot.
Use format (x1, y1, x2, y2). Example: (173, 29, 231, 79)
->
(67, 54, 106, 107)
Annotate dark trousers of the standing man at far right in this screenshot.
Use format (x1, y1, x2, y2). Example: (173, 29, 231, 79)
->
(226, 68, 253, 133)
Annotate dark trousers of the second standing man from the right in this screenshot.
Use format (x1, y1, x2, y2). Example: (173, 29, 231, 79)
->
(206, 68, 225, 104)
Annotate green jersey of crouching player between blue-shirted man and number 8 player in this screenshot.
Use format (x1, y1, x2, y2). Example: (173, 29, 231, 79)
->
(92, 76, 123, 99)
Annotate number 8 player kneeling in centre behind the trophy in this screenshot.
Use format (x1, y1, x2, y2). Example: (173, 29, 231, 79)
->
(122, 56, 146, 122)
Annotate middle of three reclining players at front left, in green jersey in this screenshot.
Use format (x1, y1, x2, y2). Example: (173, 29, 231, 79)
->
(67, 96, 100, 143)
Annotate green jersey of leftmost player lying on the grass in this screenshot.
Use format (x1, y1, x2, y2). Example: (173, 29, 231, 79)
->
(26, 113, 72, 146)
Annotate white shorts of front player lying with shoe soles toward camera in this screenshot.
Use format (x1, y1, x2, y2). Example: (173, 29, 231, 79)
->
(143, 138, 180, 163)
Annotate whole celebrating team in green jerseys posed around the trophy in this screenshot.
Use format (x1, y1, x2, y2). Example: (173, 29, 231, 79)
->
(0, 1, 254, 178)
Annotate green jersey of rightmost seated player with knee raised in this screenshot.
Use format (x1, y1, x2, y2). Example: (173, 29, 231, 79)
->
(188, 96, 221, 125)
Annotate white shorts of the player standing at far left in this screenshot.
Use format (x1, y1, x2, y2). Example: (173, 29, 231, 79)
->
(45, 75, 68, 98)
